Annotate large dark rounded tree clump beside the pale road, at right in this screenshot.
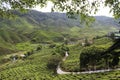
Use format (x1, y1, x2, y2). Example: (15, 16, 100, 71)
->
(80, 46, 104, 70)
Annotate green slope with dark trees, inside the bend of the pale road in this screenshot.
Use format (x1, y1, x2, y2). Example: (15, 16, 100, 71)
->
(61, 37, 120, 72)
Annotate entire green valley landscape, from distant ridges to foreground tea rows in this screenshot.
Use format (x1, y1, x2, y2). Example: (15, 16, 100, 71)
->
(0, 10, 120, 80)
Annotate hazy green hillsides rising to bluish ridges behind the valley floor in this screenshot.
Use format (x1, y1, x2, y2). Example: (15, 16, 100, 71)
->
(0, 10, 120, 53)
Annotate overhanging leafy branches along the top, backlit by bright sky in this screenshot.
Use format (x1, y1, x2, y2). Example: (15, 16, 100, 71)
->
(0, 0, 120, 18)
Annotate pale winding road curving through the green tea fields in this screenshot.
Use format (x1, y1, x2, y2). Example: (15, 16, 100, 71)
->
(57, 51, 120, 74)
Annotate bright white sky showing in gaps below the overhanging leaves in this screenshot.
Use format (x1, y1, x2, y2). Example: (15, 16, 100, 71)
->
(34, 2, 112, 17)
